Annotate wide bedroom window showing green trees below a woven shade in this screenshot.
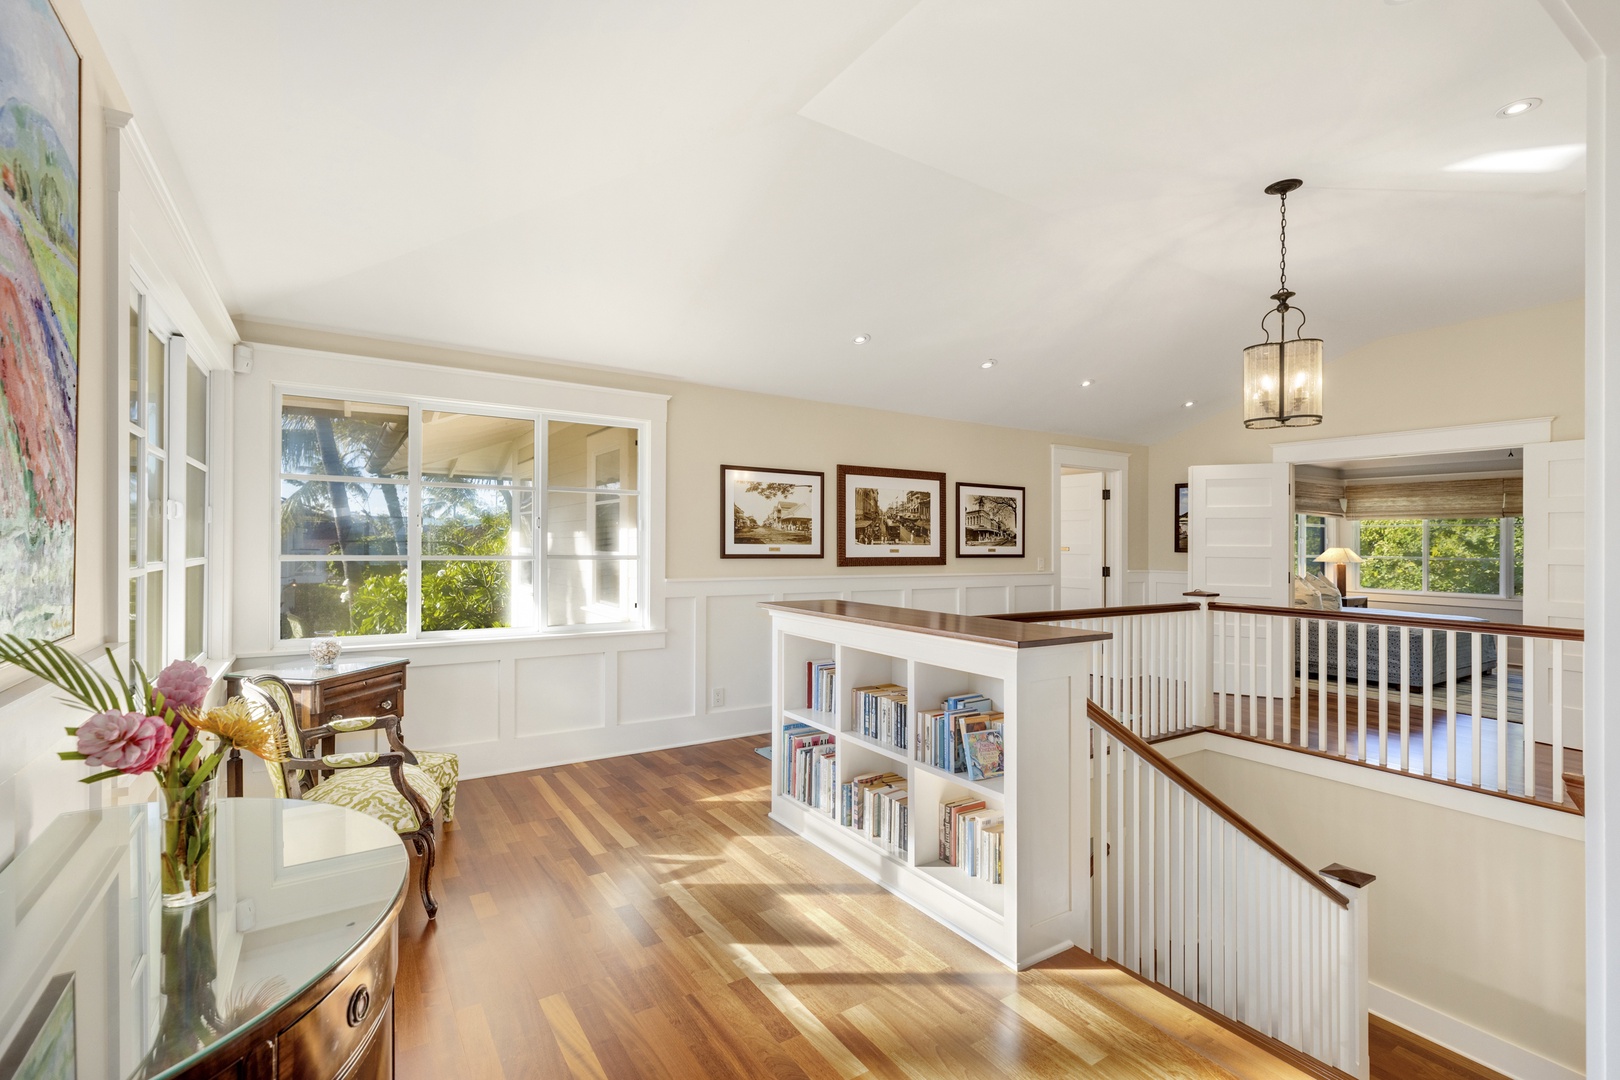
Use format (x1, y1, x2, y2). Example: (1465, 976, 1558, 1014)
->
(1356, 518, 1524, 597)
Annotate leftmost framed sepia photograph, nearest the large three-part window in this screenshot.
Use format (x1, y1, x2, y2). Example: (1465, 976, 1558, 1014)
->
(719, 465, 826, 559)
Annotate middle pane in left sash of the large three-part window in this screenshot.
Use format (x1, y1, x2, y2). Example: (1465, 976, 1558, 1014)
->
(282, 479, 410, 555)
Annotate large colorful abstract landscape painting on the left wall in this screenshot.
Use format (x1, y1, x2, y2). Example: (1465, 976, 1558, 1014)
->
(0, 0, 79, 640)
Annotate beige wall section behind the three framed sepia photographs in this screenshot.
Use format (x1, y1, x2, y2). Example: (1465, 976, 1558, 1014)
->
(237, 319, 1149, 580)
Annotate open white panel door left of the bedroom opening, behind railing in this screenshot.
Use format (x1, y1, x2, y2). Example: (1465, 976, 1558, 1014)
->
(1187, 463, 1294, 696)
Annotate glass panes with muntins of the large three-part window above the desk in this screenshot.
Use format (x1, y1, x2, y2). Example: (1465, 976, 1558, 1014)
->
(279, 393, 643, 640)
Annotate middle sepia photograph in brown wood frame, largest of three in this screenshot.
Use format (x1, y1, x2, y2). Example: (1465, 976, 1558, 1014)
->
(838, 465, 944, 567)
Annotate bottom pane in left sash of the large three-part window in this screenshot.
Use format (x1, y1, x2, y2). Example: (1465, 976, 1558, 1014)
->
(282, 560, 407, 640)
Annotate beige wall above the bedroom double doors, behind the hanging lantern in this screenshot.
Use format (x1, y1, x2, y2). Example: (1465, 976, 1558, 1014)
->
(1153, 300, 1586, 572)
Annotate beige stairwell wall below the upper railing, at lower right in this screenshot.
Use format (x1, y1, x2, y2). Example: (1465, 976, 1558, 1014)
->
(1176, 750, 1586, 1072)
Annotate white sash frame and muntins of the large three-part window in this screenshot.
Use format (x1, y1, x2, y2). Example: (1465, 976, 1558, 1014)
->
(269, 382, 661, 651)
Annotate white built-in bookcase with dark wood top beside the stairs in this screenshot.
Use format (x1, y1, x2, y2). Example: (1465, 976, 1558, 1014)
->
(763, 601, 1108, 968)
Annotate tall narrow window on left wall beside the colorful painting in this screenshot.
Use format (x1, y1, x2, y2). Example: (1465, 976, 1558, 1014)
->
(125, 283, 209, 672)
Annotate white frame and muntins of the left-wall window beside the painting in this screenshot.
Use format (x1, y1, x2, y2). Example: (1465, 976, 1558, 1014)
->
(126, 270, 219, 674)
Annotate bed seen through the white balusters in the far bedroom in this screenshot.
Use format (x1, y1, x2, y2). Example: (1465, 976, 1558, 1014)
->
(1294, 607, 1497, 690)
